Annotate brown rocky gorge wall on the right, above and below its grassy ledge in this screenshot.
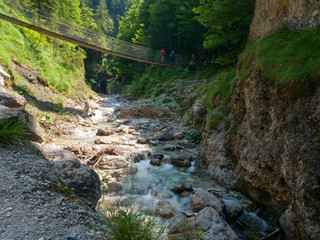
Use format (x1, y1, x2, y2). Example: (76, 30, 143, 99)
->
(200, 0, 320, 240)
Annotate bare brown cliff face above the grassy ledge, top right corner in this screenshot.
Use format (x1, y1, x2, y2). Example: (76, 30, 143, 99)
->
(249, 0, 320, 43)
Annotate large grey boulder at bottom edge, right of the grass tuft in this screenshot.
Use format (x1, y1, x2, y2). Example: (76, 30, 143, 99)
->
(169, 207, 239, 240)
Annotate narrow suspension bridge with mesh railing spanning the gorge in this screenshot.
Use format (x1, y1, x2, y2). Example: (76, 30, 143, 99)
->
(0, 0, 174, 66)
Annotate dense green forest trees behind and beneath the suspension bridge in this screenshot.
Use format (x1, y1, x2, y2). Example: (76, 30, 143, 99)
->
(21, 0, 255, 90)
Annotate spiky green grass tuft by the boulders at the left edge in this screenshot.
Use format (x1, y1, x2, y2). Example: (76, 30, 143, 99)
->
(0, 118, 31, 143)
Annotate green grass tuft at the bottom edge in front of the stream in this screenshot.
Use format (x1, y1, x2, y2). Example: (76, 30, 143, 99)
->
(102, 209, 164, 240)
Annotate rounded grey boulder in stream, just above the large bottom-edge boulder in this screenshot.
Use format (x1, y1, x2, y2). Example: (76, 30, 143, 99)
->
(191, 188, 223, 216)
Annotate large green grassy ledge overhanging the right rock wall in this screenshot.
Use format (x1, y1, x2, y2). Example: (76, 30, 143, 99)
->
(240, 27, 320, 98)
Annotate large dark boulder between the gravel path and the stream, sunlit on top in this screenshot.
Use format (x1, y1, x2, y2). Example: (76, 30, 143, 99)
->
(44, 149, 101, 207)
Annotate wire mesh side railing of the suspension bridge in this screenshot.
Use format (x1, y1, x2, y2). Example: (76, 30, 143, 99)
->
(1, 0, 154, 61)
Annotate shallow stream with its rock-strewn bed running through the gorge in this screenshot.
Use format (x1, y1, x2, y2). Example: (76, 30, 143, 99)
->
(52, 96, 272, 239)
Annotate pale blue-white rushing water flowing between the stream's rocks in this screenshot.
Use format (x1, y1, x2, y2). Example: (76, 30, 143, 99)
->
(55, 95, 258, 234)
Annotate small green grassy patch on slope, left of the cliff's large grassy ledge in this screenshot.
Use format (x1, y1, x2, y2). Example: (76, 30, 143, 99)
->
(204, 68, 236, 109)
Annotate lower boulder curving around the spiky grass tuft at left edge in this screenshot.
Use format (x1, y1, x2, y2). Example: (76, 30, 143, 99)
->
(0, 106, 45, 142)
